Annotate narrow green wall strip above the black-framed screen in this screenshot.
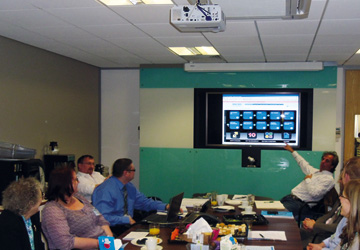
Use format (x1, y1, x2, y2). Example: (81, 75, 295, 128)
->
(140, 67, 337, 88)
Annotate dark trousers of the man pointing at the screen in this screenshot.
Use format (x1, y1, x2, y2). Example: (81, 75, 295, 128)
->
(280, 194, 314, 221)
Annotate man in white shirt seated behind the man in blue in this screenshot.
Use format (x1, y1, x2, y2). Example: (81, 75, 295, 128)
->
(77, 155, 105, 202)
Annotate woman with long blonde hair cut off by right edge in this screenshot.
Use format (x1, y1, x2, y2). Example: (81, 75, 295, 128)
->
(335, 179, 360, 250)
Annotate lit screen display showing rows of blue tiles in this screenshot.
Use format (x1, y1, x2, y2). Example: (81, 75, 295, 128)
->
(222, 93, 300, 146)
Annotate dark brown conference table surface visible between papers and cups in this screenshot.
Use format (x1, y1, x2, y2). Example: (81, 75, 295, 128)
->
(119, 199, 302, 250)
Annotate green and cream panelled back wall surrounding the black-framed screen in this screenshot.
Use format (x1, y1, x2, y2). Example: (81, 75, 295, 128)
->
(139, 67, 337, 201)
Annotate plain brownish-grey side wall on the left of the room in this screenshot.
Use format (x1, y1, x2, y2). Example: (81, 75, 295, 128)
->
(0, 37, 99, 159)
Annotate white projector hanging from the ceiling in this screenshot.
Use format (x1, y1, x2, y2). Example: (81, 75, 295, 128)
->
(170, 4, 226, 32)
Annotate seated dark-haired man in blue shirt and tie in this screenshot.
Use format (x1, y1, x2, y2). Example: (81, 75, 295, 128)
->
(92, 158, 169, 236)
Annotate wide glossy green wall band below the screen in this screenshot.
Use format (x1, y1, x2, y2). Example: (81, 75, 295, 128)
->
(140, 148, 322, 201)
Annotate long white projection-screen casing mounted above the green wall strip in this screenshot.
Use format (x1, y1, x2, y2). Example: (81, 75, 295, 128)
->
(184, 62, 324, 72)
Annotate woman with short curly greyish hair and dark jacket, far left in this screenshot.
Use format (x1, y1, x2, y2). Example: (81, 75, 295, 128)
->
(0, 177, 44, 250)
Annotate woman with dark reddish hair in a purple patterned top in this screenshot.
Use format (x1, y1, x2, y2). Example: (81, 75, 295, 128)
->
(41, 167, 113, 249)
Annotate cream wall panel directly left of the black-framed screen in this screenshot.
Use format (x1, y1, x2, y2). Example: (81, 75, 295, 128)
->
(140, 88, 194, 148)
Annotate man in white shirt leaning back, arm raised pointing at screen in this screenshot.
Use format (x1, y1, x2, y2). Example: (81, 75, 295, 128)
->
(280, 144, 339, 219)
